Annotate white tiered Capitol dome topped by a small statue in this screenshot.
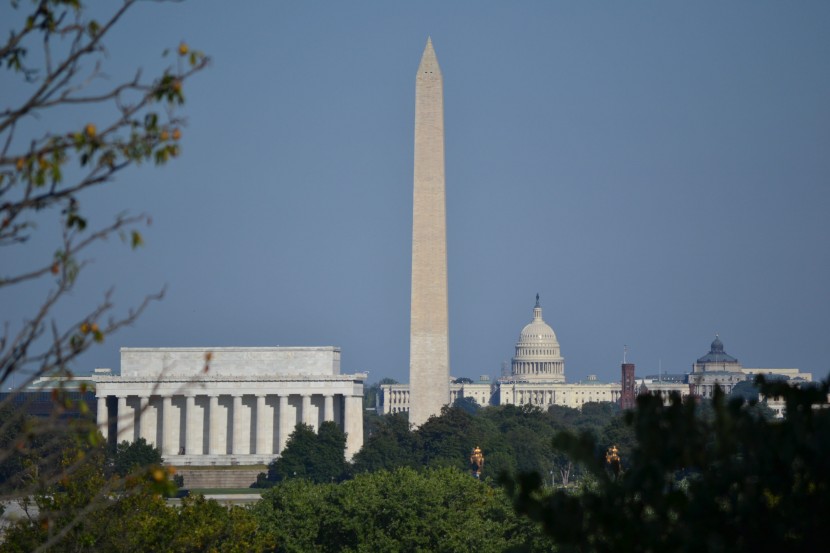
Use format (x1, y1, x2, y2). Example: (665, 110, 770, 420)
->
(512, 294, 565, 382)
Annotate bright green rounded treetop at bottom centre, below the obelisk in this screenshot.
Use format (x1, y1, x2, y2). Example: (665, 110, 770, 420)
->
(254, 468, 551, 552)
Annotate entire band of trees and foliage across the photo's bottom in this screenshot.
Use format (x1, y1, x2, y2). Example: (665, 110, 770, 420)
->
(0, 382, 830, 552)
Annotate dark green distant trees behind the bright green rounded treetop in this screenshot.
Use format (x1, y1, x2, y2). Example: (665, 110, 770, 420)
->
(259, 399, 633, 487)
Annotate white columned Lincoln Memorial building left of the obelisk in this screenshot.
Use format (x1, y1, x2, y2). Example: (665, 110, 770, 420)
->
(93, 347, 366, 465)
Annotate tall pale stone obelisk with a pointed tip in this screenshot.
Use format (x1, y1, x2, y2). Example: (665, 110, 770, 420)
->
(409, 39, 450, 427)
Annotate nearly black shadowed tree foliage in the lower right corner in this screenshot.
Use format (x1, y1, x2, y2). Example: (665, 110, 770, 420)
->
(508, 378, 830, 552)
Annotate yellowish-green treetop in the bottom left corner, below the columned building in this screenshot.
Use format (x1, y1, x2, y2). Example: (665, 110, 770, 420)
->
(0, 438, 273, 553)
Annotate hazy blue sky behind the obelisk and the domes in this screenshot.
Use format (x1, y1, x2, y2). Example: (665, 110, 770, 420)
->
(0, 0, 830, 381)
